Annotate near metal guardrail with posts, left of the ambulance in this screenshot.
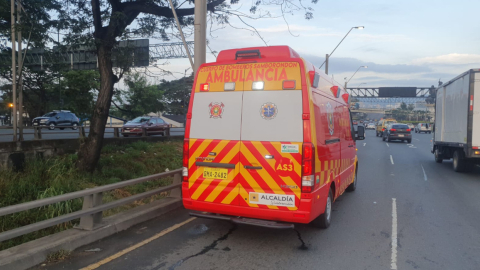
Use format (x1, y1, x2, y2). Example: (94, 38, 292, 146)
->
(0, 169, 182, 242)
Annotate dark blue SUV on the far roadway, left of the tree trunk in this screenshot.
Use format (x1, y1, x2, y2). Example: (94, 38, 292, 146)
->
(32, 110, 80, 130)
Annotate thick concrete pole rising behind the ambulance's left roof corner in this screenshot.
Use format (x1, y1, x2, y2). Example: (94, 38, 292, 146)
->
(193, 0, 207, 74)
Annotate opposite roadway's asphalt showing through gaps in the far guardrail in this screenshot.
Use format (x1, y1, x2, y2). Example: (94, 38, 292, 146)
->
(0, 127, 184, 142)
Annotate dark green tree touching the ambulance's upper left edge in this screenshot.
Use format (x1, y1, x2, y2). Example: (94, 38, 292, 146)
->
(158, 74, 193, 115)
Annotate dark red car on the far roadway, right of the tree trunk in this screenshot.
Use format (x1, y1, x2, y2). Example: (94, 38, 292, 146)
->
(122, 116, 170, 137)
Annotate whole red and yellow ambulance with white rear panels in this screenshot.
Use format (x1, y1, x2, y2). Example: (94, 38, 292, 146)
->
(182, 46, 365, 228)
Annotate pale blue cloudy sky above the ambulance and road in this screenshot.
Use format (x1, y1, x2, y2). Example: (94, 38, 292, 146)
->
(146, 0, 480, 87)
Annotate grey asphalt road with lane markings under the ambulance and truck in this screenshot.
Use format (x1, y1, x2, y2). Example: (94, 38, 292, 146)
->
(35, 130, 480, 270)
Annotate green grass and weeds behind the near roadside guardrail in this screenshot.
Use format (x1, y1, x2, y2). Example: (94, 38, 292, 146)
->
(0, 141, 182, 250)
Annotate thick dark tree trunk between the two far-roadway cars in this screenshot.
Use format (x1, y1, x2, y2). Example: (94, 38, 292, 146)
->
(77, 42, 117, 172)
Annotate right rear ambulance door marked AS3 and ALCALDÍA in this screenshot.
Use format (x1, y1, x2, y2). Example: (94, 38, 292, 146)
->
(238, 62, 303, 211)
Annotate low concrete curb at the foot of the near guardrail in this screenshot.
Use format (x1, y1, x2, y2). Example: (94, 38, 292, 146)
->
(0, 198, 182, 270)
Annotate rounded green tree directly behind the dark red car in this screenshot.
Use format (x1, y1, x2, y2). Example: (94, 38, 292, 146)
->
(114, 72, 164, 119)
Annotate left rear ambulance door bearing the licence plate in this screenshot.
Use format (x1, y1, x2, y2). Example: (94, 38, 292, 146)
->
(188, 65, 244, 205)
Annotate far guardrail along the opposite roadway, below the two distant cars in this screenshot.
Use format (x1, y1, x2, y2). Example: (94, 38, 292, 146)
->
(0, 125, 181, 140)
